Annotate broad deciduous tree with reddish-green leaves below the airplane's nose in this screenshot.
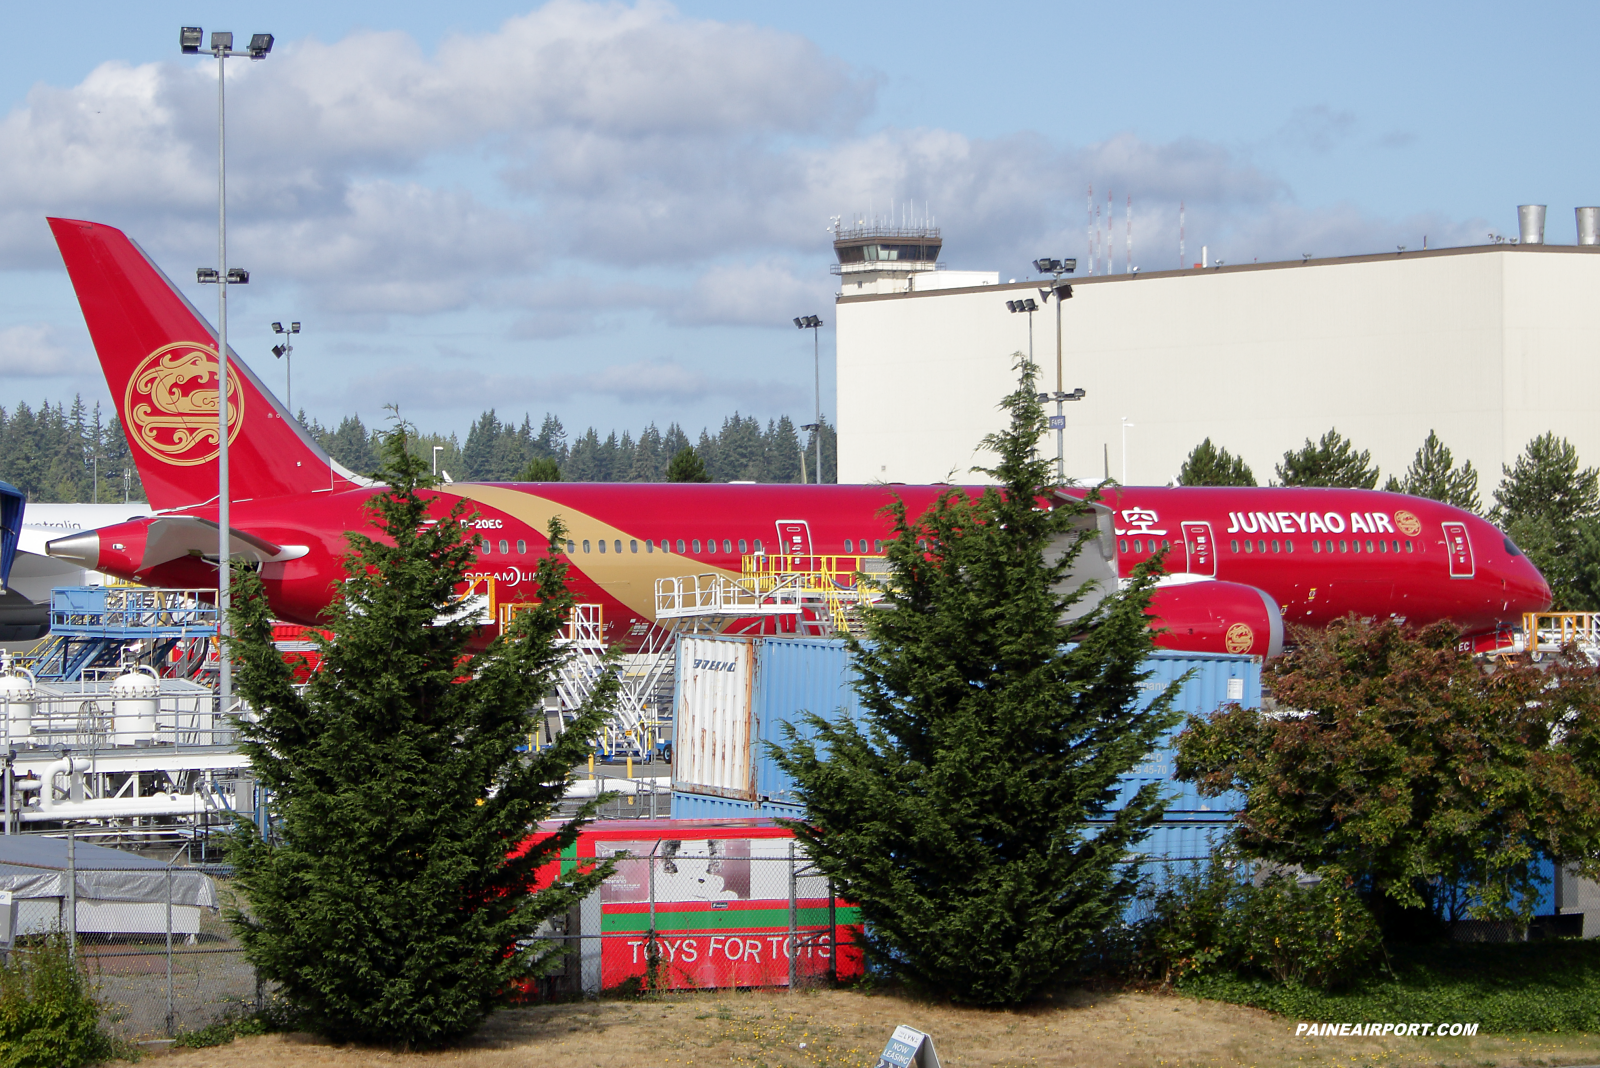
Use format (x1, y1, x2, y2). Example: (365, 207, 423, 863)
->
(1178, 617, 1600, 935)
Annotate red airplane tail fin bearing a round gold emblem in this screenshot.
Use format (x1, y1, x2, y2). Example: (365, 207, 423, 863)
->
(50, 219, 366, 510)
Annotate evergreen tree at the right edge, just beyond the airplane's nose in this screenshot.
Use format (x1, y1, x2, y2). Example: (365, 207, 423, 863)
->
(1490, 433, 1600, 611)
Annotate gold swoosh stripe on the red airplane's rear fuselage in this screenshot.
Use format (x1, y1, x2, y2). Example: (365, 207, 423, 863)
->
(443, 483, 739, 619)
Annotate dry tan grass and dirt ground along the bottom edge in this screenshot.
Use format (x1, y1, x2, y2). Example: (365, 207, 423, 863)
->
(128, 991, 1600, 1068)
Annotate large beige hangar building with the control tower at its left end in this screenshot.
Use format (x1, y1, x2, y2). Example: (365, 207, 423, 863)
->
(834, 209, 1600, 505)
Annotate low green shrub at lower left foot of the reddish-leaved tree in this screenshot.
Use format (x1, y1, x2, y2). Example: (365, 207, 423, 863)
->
(1139, 857, 1379, 988)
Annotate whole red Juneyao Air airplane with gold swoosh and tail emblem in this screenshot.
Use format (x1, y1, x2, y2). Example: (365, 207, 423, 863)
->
(48, 219, 1550, 656)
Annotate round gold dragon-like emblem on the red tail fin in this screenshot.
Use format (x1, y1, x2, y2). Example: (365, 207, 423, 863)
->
(122, 341, 245, 467)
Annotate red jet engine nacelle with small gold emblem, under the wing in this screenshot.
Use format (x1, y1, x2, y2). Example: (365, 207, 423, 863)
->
(1147, 579, 1283, 657)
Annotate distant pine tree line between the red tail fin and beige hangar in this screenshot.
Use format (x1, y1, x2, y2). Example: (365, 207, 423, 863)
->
(299, 409, 837, 483)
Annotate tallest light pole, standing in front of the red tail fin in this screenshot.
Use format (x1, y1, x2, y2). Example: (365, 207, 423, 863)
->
(187, 26, 272, 713)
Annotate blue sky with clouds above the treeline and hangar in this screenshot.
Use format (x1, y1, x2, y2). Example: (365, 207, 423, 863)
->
(0, 0, 1600, 436)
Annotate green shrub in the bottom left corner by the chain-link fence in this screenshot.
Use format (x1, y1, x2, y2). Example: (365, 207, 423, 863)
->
(0, 932, 115, 1068)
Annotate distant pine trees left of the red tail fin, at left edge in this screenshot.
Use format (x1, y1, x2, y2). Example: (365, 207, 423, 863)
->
(0, 395, 144, 504)
